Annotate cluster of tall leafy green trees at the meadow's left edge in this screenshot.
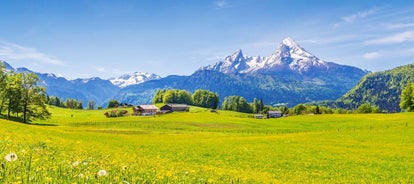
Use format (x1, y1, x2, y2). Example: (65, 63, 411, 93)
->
(0, 64, 51, 123)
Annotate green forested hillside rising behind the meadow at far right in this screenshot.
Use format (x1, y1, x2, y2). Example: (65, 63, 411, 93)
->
(337, 64, 414, 112)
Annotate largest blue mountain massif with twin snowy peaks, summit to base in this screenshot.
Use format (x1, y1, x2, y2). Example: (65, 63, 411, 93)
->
(116, 38, 368, 106)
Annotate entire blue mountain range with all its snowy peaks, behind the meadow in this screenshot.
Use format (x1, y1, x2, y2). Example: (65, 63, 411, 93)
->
(1, 38, 368, 106)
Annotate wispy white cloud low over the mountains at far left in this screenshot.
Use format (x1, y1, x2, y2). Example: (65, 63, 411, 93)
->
(0, 42, 65, 66)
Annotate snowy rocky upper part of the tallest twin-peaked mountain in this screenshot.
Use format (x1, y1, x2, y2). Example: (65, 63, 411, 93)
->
(200, 38, 338, 74)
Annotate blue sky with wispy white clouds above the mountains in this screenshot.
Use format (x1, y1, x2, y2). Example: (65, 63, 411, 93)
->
(0, 0, 414, 79)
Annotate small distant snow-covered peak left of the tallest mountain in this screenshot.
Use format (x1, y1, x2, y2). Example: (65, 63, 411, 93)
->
(109, 72, 161, 88)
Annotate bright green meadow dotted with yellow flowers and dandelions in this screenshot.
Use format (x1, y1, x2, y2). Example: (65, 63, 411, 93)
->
(0, 107, 414, 183)
